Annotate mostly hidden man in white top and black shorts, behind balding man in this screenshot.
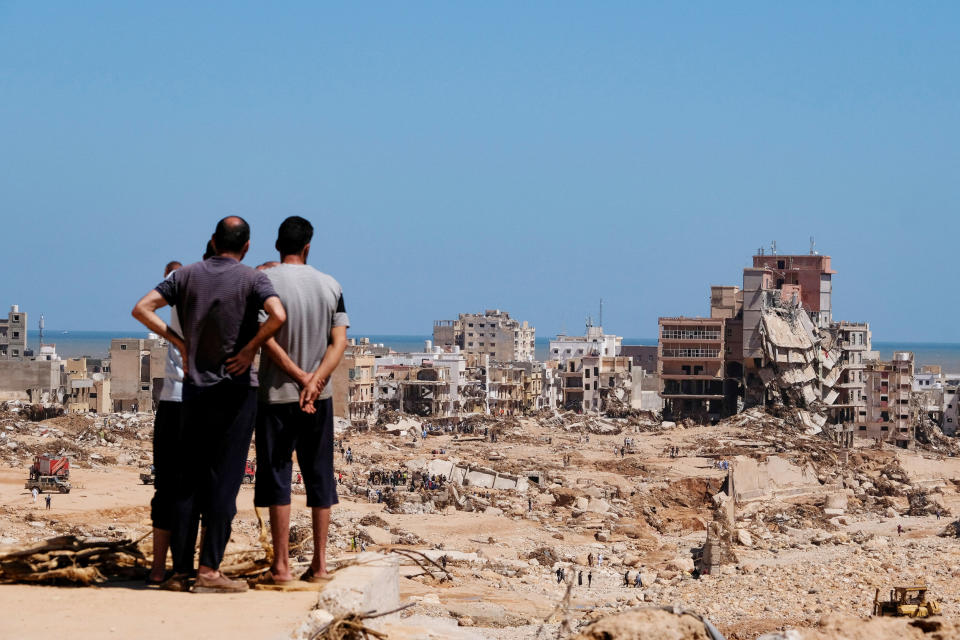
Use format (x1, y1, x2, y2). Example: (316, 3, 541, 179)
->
(147, 260, 183, 585)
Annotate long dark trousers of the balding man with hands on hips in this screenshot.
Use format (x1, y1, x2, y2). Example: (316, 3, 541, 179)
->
(170, 382, 257, 573)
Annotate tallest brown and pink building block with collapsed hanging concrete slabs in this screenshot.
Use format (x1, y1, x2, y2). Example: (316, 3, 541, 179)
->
(658, 250, 896, 438)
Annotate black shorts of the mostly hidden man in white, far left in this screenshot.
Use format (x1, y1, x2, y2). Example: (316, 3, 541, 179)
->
(150, 400, 183, 530)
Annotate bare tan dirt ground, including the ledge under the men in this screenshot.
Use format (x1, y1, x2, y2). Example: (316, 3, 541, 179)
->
(0, 408, 960, 640)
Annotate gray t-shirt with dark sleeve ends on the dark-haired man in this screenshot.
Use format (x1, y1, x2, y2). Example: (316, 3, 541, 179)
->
(260, 264, 350, 404)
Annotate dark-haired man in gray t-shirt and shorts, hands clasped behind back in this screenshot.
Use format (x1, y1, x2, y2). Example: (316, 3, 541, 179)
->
(253, 216, 350, 584)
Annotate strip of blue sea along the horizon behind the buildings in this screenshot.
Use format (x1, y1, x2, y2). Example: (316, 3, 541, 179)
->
(41, 329, 960, 373)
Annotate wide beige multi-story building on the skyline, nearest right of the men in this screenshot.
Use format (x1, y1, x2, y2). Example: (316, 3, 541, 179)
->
(433, 309, 536, 367)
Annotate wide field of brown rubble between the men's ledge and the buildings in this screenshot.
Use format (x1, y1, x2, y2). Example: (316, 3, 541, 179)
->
(0, 402, 960, 640)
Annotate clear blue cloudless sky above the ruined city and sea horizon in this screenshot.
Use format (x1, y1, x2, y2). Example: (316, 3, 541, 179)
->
(0, 1, 960, 341)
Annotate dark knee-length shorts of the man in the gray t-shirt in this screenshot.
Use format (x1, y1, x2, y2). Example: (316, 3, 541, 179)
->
(253, 398, 339, 508)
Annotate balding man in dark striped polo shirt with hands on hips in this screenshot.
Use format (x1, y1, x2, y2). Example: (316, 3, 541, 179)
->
(133, 216, 286, 592)
